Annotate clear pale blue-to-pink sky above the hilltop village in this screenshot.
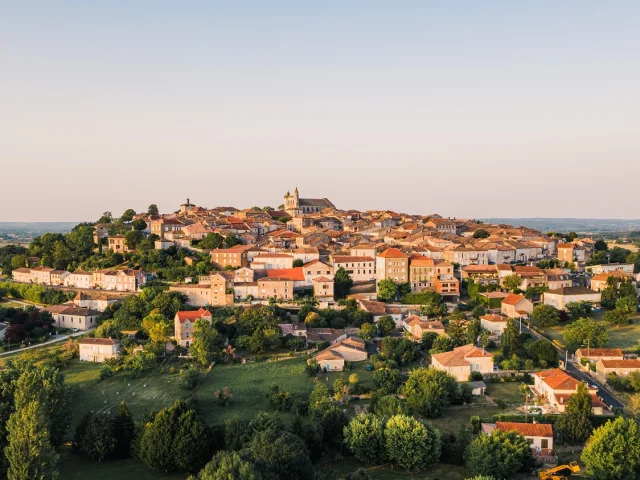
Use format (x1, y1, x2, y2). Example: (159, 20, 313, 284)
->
(0, 0, 640, 221)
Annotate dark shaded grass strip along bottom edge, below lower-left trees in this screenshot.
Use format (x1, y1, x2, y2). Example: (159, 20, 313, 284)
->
(58, 445, 187, 480)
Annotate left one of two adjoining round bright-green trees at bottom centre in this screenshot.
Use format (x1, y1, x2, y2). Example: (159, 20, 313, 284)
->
(344, 413, 385, 465)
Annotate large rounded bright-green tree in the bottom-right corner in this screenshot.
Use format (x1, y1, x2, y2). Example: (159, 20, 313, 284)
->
(580, 417, 640, 480)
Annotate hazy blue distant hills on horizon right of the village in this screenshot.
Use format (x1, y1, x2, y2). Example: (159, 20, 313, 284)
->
(482, 218, 640, 233)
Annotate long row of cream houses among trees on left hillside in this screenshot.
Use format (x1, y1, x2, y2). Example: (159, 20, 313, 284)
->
(11, 266, 151, 292)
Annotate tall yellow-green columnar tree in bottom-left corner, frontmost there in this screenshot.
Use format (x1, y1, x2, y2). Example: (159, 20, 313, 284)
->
(4, 397, 58, 480)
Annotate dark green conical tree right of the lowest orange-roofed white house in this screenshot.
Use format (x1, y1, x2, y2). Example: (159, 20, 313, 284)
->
(555, 383, 593, 445)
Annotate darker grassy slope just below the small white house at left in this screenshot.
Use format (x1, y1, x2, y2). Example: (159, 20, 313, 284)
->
(63, 360, 190, 428)
